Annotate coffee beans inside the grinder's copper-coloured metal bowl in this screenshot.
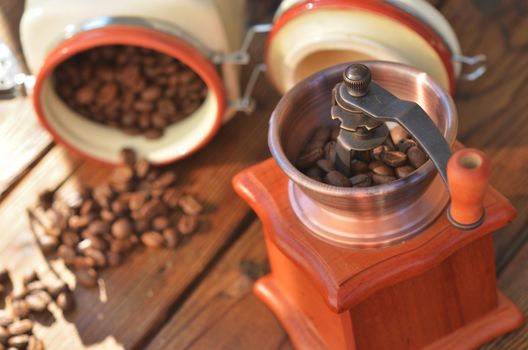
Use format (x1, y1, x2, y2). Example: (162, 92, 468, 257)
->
(295, 125, 429, 187)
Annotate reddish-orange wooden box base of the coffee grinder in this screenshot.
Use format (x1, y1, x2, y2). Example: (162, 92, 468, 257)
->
(234, 159, 524, 350)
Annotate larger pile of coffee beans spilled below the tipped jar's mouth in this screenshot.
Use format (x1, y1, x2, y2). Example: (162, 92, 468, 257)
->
(32, 149, 207, 288)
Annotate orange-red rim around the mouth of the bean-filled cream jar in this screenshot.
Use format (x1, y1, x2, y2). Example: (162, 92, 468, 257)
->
(33, 25, 225, 165)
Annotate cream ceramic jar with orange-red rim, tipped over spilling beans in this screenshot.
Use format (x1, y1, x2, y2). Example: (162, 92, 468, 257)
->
(20, 0, 246, 163)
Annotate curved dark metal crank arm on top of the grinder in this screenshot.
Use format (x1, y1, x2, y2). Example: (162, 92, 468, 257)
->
(339, 81, 451, 185)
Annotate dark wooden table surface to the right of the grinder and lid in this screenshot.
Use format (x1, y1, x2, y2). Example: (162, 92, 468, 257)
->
(442, 0, 528, 270)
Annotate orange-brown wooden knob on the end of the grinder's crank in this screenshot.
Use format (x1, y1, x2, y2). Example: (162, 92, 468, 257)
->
(447, 148, 491, 228)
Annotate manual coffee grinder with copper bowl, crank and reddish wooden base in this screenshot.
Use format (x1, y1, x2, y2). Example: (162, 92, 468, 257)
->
(233, 61, 523, 350)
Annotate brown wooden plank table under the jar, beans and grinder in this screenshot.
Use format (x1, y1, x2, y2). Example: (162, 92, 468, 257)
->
(0, 0, 528, 349)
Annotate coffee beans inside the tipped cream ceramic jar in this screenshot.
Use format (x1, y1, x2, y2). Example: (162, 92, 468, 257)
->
(54, 45, 208, 139)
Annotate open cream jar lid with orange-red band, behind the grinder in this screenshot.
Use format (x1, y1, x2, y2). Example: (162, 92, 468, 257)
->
(266, 0, 461, 93)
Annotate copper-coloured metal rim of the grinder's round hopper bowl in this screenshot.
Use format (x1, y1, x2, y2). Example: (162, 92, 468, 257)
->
(268, 61, 458, 198)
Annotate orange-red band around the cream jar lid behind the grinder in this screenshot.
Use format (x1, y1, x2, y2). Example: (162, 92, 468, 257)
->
(266, 0, 456, 95)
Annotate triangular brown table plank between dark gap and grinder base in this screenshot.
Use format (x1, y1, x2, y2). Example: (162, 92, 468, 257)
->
(144, 222, 291, 350)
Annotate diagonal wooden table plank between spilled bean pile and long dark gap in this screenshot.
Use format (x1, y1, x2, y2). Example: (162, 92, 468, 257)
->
(21, 77, 274, 349)
